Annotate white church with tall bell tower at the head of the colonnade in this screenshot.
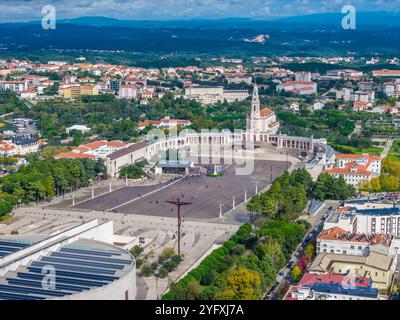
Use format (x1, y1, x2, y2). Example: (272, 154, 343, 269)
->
(245, 85, 279, 143)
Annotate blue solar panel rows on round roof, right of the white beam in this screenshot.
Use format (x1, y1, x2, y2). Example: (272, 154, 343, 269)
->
(0, 245, 132, 300)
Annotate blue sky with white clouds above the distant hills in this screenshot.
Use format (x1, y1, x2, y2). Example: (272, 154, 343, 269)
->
(0, 0, 400, 22)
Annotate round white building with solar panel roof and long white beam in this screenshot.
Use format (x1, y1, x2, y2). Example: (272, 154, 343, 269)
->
(0, 219, 136, 300)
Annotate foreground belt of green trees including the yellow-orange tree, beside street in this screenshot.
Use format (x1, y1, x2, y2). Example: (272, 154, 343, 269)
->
(163, 219, 309, 300)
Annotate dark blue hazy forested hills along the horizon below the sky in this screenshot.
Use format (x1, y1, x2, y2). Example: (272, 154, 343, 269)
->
(0, 12, 400, 56)
